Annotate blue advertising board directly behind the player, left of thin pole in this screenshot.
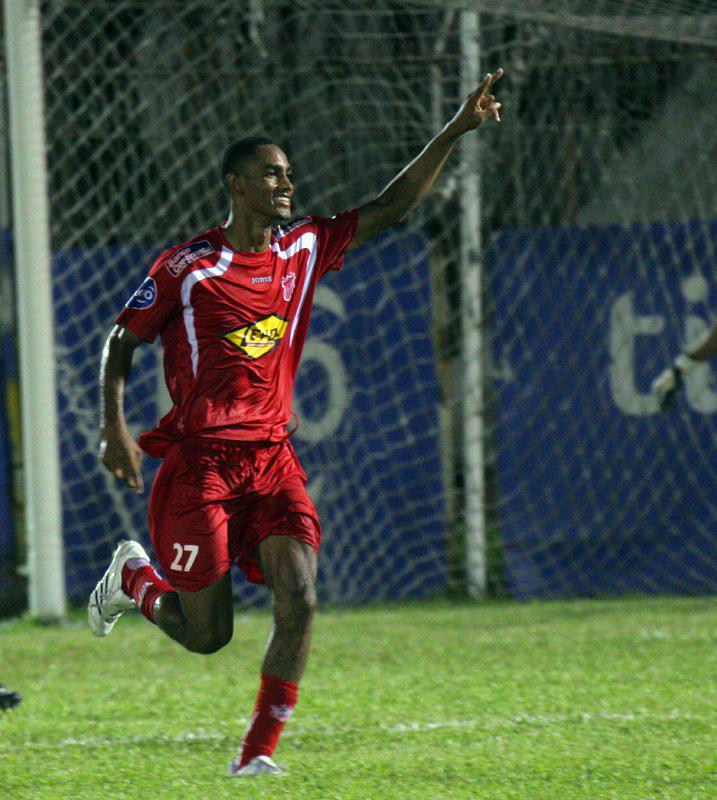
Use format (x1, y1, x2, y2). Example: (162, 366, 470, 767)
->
(53, 228, 448, 603)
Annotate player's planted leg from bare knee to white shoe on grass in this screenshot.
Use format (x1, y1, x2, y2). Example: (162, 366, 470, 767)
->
(229, 535, 317, 775)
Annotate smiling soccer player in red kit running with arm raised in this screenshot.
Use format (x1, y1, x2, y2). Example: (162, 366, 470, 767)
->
(88, 70, 503, 776)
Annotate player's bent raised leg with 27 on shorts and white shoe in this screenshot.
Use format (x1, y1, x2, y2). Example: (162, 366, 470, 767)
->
(89, 446, 234, 653)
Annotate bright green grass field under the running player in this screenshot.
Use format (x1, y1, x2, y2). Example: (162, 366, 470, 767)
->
(0, 598, 717, 800)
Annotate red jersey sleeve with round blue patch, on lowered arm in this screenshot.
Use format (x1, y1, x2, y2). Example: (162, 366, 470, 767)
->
(115, 250, 182, 342)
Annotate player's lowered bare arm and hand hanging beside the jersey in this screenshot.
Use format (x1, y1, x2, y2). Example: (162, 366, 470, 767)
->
(100, 325, 144, 492)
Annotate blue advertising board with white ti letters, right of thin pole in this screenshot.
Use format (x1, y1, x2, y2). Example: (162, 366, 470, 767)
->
(486, 221, 717, 597)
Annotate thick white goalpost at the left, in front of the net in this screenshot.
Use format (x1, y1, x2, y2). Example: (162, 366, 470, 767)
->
(4, 0, 66, 621)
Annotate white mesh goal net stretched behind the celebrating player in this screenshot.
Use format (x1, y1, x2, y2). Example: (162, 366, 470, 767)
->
(22, 0, 717, 604)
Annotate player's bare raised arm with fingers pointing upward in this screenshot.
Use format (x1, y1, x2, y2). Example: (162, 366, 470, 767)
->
(349, 69, 503, 249)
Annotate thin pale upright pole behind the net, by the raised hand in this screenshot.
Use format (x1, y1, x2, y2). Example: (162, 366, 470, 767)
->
(459, 6, 487, 597)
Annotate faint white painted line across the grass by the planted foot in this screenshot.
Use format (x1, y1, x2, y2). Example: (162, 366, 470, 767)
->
(0, 710, 717, 755)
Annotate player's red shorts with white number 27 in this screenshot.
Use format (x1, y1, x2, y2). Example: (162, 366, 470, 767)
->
(149, 439, 321, 592)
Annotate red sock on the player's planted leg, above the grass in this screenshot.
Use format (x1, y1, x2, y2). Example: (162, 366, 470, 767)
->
(240, 675, 299, 767)
